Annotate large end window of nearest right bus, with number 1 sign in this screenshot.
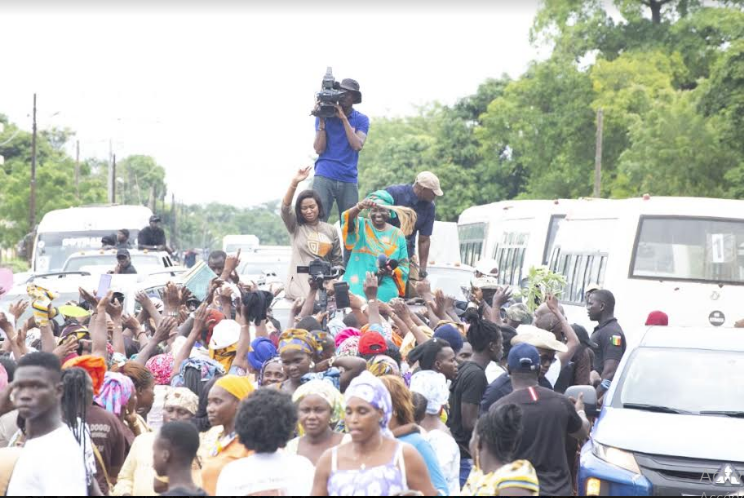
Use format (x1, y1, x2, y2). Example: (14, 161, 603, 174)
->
(632, 217, 744, 285)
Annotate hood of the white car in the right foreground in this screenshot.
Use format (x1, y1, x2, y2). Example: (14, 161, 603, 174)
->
(593, 408, 744, 462)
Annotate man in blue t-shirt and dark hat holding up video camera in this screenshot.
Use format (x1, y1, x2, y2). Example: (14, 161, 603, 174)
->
(313, 79, 369, 221)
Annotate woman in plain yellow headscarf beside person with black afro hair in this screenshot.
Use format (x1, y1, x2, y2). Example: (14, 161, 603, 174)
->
(199, 375, 254, 496)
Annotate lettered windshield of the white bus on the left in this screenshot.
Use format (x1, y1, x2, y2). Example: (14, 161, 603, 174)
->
(35, 230, 119, 273)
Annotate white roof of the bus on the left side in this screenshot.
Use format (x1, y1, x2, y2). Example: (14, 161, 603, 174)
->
(38, 205, 152, 233)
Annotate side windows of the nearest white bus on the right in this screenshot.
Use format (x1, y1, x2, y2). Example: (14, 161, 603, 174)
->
(550, 253, 608, 304)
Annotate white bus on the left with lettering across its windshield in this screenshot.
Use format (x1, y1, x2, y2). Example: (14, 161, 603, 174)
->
(32, 205, 152, 274)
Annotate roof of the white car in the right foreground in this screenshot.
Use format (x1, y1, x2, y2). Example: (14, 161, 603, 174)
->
(637, 327, 744, 352)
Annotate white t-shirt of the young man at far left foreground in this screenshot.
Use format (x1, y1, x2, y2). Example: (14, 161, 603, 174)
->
(7, 425, 88, 496)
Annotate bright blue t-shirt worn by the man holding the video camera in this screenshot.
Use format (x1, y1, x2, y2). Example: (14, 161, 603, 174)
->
(315, 110, 369, 183)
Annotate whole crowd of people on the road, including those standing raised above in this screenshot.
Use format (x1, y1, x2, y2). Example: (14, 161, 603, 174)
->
(0, 76, 626, 496)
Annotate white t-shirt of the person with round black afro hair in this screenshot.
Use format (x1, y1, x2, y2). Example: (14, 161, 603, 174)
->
(216, 450, 315, 496)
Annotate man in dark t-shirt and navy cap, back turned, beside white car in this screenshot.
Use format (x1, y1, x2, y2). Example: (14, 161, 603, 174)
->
(491, 344, 591, 496)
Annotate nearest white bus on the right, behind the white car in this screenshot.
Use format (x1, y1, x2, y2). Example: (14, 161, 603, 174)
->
(550, 196, 744, 330)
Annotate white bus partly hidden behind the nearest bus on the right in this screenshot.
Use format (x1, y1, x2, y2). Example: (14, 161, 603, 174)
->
(458, 199, 607, 287)
